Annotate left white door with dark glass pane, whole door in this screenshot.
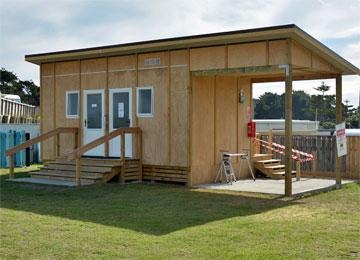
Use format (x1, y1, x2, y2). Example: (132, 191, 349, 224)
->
(83, 89, 105, 156)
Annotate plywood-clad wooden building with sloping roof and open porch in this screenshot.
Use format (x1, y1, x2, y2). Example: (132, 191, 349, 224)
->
(18, 25, 360, 194)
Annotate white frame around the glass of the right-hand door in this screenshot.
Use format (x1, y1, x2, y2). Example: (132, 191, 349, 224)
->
(108, 87, 133, 156)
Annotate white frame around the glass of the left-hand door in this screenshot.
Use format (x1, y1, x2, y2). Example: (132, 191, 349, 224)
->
(81, 89, 106, 156)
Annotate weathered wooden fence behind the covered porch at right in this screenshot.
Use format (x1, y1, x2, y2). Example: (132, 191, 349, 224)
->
(261, 135, 360, 179)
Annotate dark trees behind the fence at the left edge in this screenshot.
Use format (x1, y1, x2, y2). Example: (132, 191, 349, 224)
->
(0, 68, 40, 106)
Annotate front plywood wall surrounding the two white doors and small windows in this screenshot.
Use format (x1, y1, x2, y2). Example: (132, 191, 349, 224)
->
(41, 50, 189, 166)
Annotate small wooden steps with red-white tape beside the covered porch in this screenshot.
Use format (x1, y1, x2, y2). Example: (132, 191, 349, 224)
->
(252, 154, 296, 179)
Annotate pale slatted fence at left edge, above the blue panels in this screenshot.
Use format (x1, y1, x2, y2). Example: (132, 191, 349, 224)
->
(0, 98, 39, 124)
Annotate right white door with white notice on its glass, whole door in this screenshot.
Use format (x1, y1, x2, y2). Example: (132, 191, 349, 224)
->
(109, 88, 132, 157)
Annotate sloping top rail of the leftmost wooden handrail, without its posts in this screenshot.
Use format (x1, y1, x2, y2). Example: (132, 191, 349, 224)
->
(5, 127, 79, 156)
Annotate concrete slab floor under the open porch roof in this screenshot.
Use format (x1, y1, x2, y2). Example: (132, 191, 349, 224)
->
(194, 178, 354, 195)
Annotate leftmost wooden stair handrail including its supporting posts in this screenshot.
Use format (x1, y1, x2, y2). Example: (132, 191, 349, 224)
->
(5, 127, 79, 179)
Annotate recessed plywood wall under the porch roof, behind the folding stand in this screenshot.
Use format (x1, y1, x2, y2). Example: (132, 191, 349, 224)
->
(191, 76, 251, 185)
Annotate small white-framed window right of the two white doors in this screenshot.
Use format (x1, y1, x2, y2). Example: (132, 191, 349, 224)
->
(136, 87, 154, 117)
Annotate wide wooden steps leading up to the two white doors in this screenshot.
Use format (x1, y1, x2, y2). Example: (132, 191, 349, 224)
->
(30, 158, 139, 184)
